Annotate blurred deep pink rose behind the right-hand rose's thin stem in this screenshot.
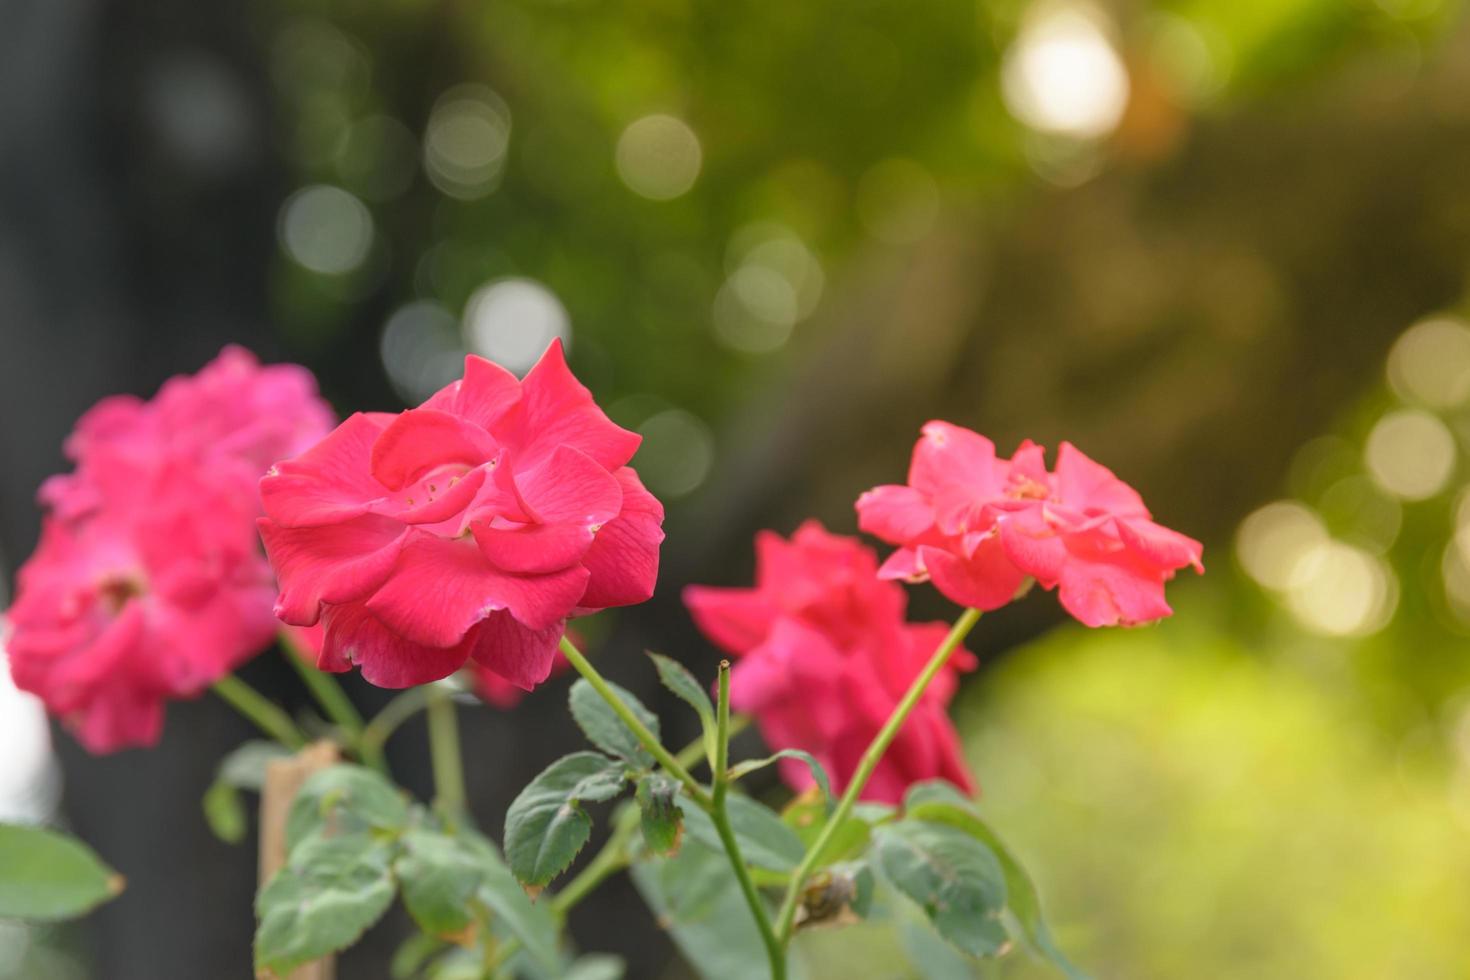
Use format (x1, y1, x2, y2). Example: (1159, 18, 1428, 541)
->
(684, 522, 975, 802)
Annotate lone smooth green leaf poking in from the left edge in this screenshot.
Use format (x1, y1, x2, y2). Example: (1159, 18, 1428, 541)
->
(0, 824, 123, 921)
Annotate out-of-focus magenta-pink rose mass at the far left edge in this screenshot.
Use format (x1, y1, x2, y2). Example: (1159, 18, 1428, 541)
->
(7, 348, 331, 752)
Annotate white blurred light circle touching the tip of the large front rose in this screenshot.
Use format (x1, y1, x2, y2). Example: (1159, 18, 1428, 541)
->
(465, 279, 572, 375)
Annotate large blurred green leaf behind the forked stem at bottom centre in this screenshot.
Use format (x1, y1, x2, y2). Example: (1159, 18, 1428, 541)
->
(629, 846, 804, 980)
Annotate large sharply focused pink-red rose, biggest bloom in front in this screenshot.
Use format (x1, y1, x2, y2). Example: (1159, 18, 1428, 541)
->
(260, 342, 663, 691)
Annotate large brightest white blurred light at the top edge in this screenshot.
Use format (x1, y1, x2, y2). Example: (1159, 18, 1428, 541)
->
(1001, 3, 1129, 140)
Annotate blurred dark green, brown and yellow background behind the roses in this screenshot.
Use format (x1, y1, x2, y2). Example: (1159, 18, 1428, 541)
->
(0, 0, 1470, 980)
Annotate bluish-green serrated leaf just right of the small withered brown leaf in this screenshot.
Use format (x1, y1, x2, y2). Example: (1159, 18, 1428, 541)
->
(873, 820, 1007, 956)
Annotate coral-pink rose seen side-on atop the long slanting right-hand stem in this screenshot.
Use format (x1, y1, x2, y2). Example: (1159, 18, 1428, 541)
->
(857, 422, 1204, 626)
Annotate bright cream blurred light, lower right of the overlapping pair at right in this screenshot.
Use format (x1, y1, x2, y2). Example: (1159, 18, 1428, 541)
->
(1286, 541, 1398, 636)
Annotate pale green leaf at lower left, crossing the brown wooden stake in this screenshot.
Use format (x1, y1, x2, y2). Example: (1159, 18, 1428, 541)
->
(256, 832, 397, 976)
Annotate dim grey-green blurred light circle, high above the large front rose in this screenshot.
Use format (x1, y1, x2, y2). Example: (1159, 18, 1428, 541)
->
(423, 85, 510, 200)
